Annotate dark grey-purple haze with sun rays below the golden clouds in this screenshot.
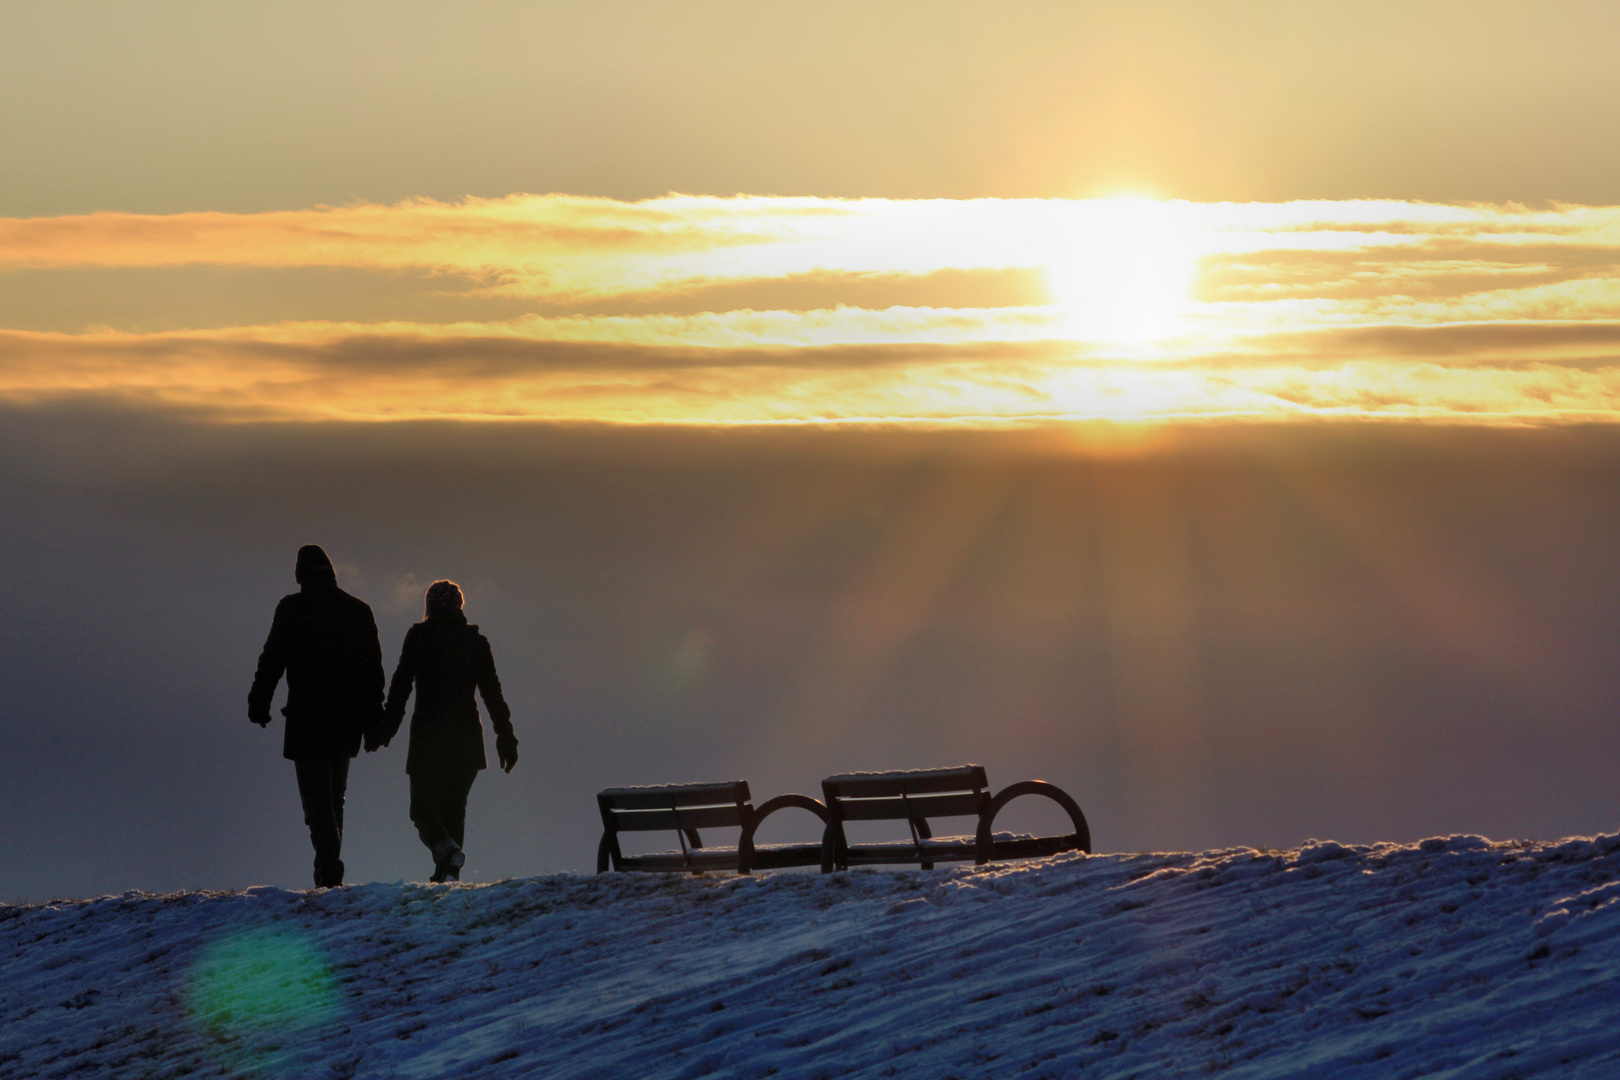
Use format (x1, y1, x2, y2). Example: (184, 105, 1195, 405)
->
(0, 406, 1620, 900)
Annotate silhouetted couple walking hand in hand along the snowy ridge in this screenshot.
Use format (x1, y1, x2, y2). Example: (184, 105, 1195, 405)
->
(248, 544, 517, 887)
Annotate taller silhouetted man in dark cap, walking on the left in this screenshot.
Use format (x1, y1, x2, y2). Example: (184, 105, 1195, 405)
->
(248, 544, 382, 887)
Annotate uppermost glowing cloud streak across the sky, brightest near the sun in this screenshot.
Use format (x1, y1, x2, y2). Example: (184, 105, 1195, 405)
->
(9, 194, 1620, 300)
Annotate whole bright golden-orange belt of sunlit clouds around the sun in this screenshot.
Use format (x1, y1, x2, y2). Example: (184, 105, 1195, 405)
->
(0, 196, 1620, 426)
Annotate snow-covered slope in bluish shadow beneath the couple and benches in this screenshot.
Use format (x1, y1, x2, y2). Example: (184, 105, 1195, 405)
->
(0, 836, 1620, 1080)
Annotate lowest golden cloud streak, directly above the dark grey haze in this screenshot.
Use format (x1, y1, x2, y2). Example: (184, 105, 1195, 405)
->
(0, 324, 1620, 424)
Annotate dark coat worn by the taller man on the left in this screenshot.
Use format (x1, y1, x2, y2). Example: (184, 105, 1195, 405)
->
(248, 573, 382, 761)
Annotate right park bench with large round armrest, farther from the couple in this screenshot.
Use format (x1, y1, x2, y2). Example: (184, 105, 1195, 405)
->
(821, 764, 1092, 873)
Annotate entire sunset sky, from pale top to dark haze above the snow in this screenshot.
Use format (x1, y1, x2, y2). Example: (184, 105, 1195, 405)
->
(0, 2, 1620, 900)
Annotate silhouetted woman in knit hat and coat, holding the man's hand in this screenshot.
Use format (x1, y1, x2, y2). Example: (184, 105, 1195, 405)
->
(366, 581, 517, 881)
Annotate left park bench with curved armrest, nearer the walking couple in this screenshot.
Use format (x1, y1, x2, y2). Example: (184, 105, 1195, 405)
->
(596, 780, 826, 874)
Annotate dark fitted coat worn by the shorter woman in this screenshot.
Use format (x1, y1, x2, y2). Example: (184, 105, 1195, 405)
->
(381, 610, 512, 776)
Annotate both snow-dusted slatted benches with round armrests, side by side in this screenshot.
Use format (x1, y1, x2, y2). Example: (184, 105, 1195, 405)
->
(596, 764, 1092, 874)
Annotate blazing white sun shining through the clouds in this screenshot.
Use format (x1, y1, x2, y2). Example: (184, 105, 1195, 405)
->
(1047, 196, 1196, 345)
